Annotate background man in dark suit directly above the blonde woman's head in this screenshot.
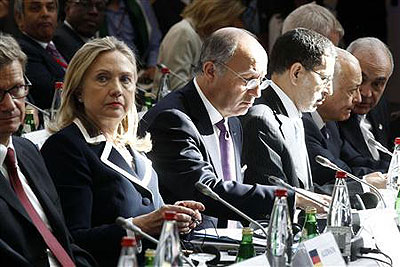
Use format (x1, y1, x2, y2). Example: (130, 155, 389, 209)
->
(53, 0, 106, 62)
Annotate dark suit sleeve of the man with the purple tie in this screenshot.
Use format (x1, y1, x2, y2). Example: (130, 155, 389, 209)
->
(143, 110, 293, 220)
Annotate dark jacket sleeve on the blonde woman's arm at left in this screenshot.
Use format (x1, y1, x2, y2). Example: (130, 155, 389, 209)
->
(41, 135, 126, 260)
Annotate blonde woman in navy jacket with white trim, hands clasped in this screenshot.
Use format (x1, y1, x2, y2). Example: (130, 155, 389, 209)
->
(42, 37, 204, 266)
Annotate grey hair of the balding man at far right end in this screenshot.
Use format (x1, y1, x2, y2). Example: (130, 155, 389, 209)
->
(346, 37, 394, 76)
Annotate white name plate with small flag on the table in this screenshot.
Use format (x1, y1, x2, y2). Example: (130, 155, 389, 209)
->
(292, 232, 346, 267)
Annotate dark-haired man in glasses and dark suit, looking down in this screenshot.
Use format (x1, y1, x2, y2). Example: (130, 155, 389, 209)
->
(242, 29, 336, 194)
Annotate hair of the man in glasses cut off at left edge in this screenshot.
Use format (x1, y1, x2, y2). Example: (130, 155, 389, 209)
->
(0, 33, 27, 71)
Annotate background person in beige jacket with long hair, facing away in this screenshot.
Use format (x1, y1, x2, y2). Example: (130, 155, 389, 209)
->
(153, 0, 246, 92)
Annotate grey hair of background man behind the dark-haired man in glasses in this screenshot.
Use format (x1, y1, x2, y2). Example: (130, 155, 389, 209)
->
(282, 3, 344, 41)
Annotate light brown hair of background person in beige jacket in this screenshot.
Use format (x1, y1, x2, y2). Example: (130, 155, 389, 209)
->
(181, 0, 246, 38)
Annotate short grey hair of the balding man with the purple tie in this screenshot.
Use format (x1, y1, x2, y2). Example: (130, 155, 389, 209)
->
(194, 29, 255, 75)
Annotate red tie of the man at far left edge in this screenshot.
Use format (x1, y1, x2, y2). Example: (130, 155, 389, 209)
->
(5, 148, 75, 267)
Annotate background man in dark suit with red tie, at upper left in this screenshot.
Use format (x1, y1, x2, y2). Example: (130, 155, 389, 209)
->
(14, 0, 68, 109)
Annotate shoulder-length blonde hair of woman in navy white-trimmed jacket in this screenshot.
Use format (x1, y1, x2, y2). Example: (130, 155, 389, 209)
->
(49, 37, 151, 152)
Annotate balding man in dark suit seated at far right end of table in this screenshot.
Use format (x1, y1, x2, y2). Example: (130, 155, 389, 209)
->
(339, 37, 394, 168)
